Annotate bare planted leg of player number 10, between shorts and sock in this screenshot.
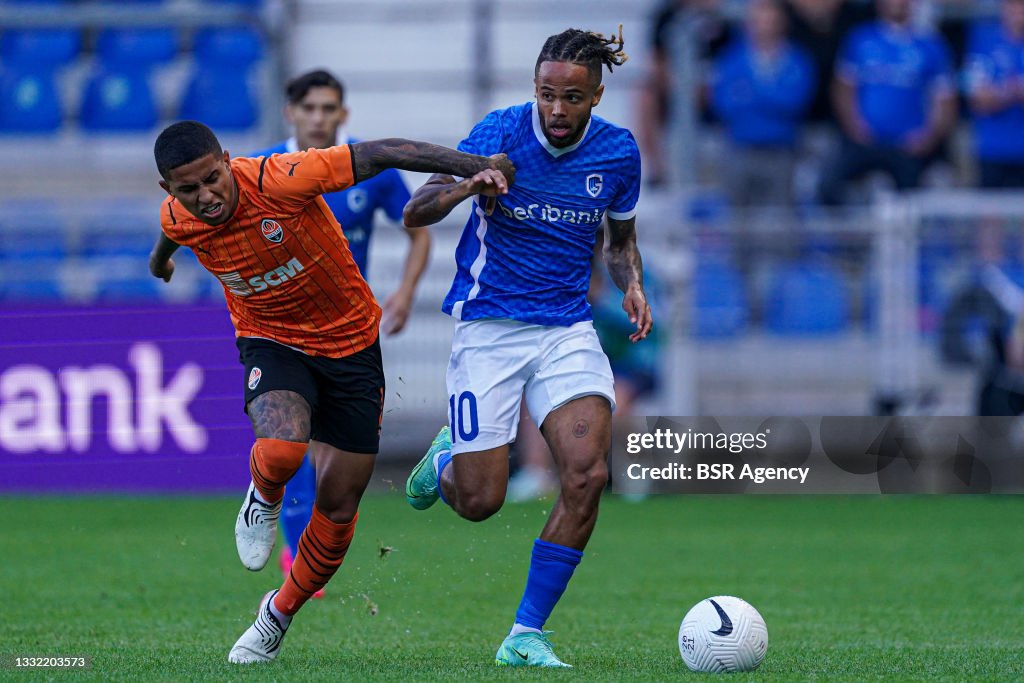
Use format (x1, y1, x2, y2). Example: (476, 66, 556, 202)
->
(541, 396, 611, 550)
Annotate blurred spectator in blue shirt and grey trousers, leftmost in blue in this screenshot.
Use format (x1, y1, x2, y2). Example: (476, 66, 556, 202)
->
(711, 0, 815, 207)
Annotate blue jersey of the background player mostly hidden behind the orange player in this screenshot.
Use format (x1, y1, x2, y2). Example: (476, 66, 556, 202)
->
(249, 137, 410, 278)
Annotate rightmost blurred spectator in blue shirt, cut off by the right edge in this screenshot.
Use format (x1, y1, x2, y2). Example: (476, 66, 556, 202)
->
(965, 0, 1024, 187)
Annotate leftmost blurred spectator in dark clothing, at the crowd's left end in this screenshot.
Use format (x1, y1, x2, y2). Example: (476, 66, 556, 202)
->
(637, 0, 731, 185)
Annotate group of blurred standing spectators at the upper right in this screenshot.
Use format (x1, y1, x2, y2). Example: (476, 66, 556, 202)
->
(638, 0, 1024, 206)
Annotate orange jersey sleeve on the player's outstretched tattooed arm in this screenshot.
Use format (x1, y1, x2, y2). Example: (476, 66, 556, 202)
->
(256, 144, 354, 207)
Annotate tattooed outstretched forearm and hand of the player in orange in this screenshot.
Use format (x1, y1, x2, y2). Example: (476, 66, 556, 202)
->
(351, 137, 515, 183)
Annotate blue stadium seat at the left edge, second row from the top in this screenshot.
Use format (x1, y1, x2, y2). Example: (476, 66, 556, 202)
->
(0, 69, 63, 133)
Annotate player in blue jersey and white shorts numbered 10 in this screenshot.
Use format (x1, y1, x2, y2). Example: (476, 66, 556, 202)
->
(406, 28, 652, 667)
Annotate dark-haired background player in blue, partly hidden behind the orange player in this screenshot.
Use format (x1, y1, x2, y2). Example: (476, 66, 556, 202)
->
(252, 70, 430, 598)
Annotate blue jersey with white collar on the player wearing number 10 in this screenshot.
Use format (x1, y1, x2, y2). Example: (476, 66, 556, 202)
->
(442, 102, 640, 326)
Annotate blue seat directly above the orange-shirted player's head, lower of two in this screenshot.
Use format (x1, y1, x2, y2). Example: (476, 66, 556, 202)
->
(180, 66, 259, 130)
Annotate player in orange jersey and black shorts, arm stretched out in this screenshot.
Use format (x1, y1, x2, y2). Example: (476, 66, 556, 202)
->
(150, 121, 514, 664)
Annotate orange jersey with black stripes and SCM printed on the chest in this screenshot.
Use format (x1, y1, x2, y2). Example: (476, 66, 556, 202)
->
(160, 145, 381, 357)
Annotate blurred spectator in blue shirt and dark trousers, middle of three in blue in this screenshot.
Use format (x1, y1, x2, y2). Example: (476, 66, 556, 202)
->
(820, 0, 956, 205)
